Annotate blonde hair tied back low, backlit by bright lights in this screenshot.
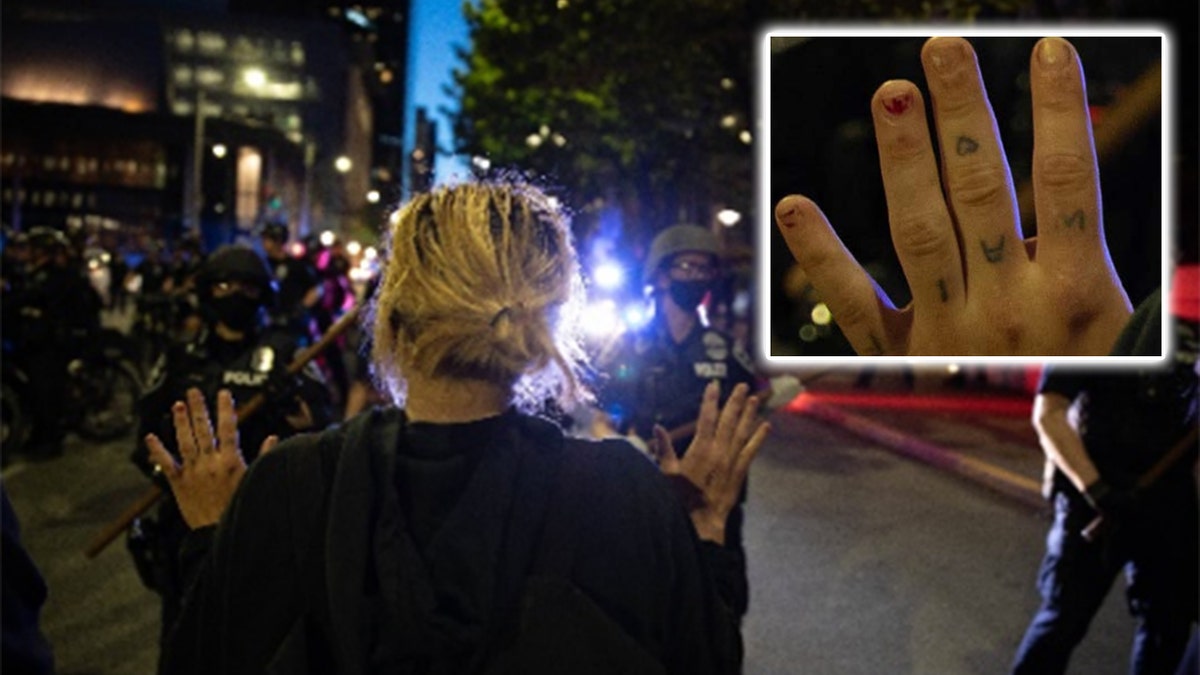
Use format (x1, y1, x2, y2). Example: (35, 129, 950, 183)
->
(373, 181, 584, 404)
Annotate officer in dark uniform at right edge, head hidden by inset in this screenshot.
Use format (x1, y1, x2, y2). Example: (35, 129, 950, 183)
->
(1013, 281, 1200, 675)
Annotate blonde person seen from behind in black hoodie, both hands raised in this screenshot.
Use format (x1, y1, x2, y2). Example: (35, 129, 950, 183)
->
(150, 183, 767, 674)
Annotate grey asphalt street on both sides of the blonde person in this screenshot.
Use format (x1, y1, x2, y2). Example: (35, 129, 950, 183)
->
(4, 386, 1133, 675)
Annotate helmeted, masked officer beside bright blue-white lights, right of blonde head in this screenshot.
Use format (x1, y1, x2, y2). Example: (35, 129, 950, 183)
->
(596, 225, 762, 614)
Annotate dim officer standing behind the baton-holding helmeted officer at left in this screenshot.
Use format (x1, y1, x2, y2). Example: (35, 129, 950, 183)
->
(262, 222, 322, 344)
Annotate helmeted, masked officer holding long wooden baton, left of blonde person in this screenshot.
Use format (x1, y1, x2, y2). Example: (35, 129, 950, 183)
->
(128, 246, 331, 658)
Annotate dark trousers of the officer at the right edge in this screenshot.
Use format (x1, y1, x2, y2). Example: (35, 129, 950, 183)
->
(1013, 474, 1200, 675)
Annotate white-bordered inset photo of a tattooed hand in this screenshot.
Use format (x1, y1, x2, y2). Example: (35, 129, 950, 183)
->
(758, 25, 1171, 365)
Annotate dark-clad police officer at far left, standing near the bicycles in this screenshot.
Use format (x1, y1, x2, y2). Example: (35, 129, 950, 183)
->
(12, 227, 101, 459)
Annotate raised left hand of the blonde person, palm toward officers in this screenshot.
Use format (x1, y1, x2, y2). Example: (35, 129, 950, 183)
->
(145, 389, 278, 530)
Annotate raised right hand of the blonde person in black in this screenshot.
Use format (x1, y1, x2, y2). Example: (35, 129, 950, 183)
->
(654, 382, 770, 544)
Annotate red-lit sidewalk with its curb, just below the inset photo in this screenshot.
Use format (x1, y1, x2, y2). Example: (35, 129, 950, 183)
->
(784, 371, 1045, 508)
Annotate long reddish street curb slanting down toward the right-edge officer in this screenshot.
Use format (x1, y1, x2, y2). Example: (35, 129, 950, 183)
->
(800, 401, 1045, 509)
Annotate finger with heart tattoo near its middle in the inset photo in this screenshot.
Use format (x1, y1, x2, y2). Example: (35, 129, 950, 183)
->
(920, 37, 1028, 285)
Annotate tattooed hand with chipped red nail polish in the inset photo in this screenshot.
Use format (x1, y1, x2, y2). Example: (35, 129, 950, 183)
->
(775, 37, 1132, 357)
